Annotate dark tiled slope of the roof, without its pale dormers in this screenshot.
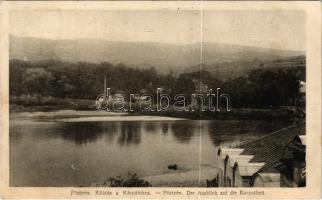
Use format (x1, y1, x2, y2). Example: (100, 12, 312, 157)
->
(238, 122, 305, 173)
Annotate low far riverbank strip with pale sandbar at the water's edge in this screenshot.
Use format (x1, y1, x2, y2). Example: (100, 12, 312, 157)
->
(10, 104, 305, 121)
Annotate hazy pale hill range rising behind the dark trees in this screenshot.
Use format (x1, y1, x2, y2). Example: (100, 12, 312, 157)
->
(10, 35, 304, 75)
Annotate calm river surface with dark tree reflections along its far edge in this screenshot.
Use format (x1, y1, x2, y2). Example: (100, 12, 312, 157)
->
(10, 120, 290, 186)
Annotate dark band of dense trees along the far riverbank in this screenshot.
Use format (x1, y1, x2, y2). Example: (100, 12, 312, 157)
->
(9, 60, 305, 108)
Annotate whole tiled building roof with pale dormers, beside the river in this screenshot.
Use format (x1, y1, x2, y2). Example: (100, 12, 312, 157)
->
(218, 122, 306, 183)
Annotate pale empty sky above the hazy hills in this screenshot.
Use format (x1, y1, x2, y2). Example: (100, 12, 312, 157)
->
(9, 10, 305, 51)
